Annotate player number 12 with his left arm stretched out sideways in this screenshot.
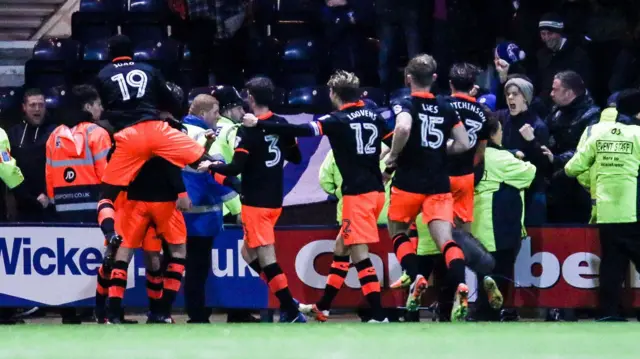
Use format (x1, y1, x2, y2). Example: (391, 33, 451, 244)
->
(244, 71, 391, 322)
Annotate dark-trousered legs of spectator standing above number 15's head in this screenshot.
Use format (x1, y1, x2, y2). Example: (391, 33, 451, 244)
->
(376, 0, 420, 89)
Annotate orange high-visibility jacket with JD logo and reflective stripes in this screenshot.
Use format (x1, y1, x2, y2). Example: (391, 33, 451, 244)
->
(45, 122, 111, 222)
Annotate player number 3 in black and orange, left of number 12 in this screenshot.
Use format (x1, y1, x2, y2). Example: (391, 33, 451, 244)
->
(199, 77, 306, 322)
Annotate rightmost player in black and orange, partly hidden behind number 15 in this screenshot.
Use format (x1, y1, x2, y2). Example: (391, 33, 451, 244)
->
(449, 63, 489, 233)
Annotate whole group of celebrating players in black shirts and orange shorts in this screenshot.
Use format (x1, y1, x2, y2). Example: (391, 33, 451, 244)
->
(96, 35, 502, 324)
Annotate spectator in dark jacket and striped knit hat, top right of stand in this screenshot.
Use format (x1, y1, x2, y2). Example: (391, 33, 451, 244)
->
(535, 13, 592, 107)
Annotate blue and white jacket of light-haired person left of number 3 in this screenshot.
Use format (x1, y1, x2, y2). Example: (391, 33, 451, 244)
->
(182, 115, 237, 237)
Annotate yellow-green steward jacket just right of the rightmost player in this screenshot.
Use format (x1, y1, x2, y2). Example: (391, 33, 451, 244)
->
(471, 144, 536, 252)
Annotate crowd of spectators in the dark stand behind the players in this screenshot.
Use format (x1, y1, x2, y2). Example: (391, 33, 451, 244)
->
(0, 0, 640, 225)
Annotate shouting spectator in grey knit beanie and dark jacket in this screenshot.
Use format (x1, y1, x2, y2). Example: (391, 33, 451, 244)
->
(496, 77, 549, 226)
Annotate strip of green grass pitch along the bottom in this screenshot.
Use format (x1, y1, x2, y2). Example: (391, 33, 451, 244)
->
(0, 322, 640, 359)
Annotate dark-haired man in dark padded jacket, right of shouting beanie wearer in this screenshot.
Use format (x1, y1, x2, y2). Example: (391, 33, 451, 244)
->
(543, 71, 600, 223)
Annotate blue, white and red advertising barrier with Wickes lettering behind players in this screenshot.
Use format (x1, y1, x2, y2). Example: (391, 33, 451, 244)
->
(0, 224, 640, 309)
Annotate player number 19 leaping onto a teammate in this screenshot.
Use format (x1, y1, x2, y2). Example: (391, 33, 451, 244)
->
(96, 35, 208, 260)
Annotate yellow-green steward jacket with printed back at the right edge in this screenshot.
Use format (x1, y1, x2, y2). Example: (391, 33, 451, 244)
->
(564, 116, 640, 223)
